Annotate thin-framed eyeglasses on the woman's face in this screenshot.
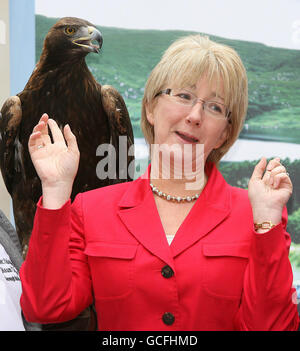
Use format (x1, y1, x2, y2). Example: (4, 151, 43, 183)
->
(154, 89, 231, 120)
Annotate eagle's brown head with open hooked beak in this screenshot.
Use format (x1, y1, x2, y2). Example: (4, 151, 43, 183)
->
(43, 17, 103, 60)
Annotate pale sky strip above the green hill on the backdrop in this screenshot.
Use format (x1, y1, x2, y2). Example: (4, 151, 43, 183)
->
(35, 0, 300, 49)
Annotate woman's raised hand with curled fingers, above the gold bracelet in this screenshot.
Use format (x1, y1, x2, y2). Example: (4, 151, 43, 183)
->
(248, 157, 293, 228)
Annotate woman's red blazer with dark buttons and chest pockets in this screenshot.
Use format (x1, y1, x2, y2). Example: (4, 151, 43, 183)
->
(20, 164, 298, 331)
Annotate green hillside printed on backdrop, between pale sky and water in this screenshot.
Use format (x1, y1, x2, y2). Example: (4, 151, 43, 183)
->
(36, 15, 300, 143)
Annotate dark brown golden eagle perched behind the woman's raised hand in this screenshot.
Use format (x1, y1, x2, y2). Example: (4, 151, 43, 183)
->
(0, 17, 133, 256)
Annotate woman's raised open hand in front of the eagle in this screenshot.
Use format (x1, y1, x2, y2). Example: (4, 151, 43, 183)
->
(28, 114, 79, 208)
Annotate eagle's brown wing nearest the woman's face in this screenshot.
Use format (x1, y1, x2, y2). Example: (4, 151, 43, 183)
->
(101, 85, 134, 181)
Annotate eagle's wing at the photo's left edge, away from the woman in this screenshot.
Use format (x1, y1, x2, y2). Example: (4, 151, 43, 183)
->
(0, 96, 22, 195)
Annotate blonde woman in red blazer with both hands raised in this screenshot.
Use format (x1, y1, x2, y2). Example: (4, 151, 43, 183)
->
(21, 35, 298, 331)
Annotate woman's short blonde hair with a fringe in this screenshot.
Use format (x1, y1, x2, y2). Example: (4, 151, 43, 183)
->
(141, 34, 248, 164)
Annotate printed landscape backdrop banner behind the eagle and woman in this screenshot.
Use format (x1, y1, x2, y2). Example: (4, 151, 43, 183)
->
(3, 0, 300, 288)
